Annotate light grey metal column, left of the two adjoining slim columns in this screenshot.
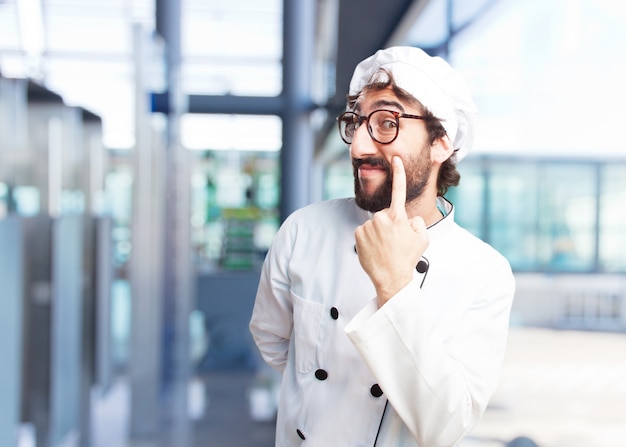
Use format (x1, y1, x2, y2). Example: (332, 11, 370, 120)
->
(129, 25, 163, 438)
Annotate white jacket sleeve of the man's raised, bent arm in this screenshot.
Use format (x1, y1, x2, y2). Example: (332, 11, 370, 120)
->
(346, 262, 515, 446)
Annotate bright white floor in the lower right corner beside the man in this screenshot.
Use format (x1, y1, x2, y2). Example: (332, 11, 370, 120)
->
(461, 328, 626, 447)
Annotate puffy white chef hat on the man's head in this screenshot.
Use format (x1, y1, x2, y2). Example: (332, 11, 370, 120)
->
(350, 47, 477, 160)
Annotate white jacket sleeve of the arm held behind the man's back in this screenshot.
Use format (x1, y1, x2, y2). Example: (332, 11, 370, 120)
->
(249, 221, 293, 373)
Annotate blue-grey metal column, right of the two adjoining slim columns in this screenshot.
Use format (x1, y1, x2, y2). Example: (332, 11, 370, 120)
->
(156, 0, 195, 447)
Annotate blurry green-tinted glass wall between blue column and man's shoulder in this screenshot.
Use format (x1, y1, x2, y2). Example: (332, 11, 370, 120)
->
(191, 151, 280, 271)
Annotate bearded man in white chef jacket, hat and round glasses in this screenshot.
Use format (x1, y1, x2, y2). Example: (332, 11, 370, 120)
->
(250, 47, 514, 447)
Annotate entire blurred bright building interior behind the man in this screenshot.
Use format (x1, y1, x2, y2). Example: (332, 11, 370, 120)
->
(0, 0, 626, 447)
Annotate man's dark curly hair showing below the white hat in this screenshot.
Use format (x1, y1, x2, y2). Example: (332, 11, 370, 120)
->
(348, 69, 461, 196)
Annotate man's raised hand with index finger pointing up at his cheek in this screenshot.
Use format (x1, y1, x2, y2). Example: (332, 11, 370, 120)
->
(354, 156, 428, 306)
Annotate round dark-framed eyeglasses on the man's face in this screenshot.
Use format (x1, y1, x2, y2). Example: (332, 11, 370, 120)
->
(337, 110, 426, 144)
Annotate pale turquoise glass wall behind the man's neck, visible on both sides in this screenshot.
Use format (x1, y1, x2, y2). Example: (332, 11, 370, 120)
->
(325, 155, 626, 273)
